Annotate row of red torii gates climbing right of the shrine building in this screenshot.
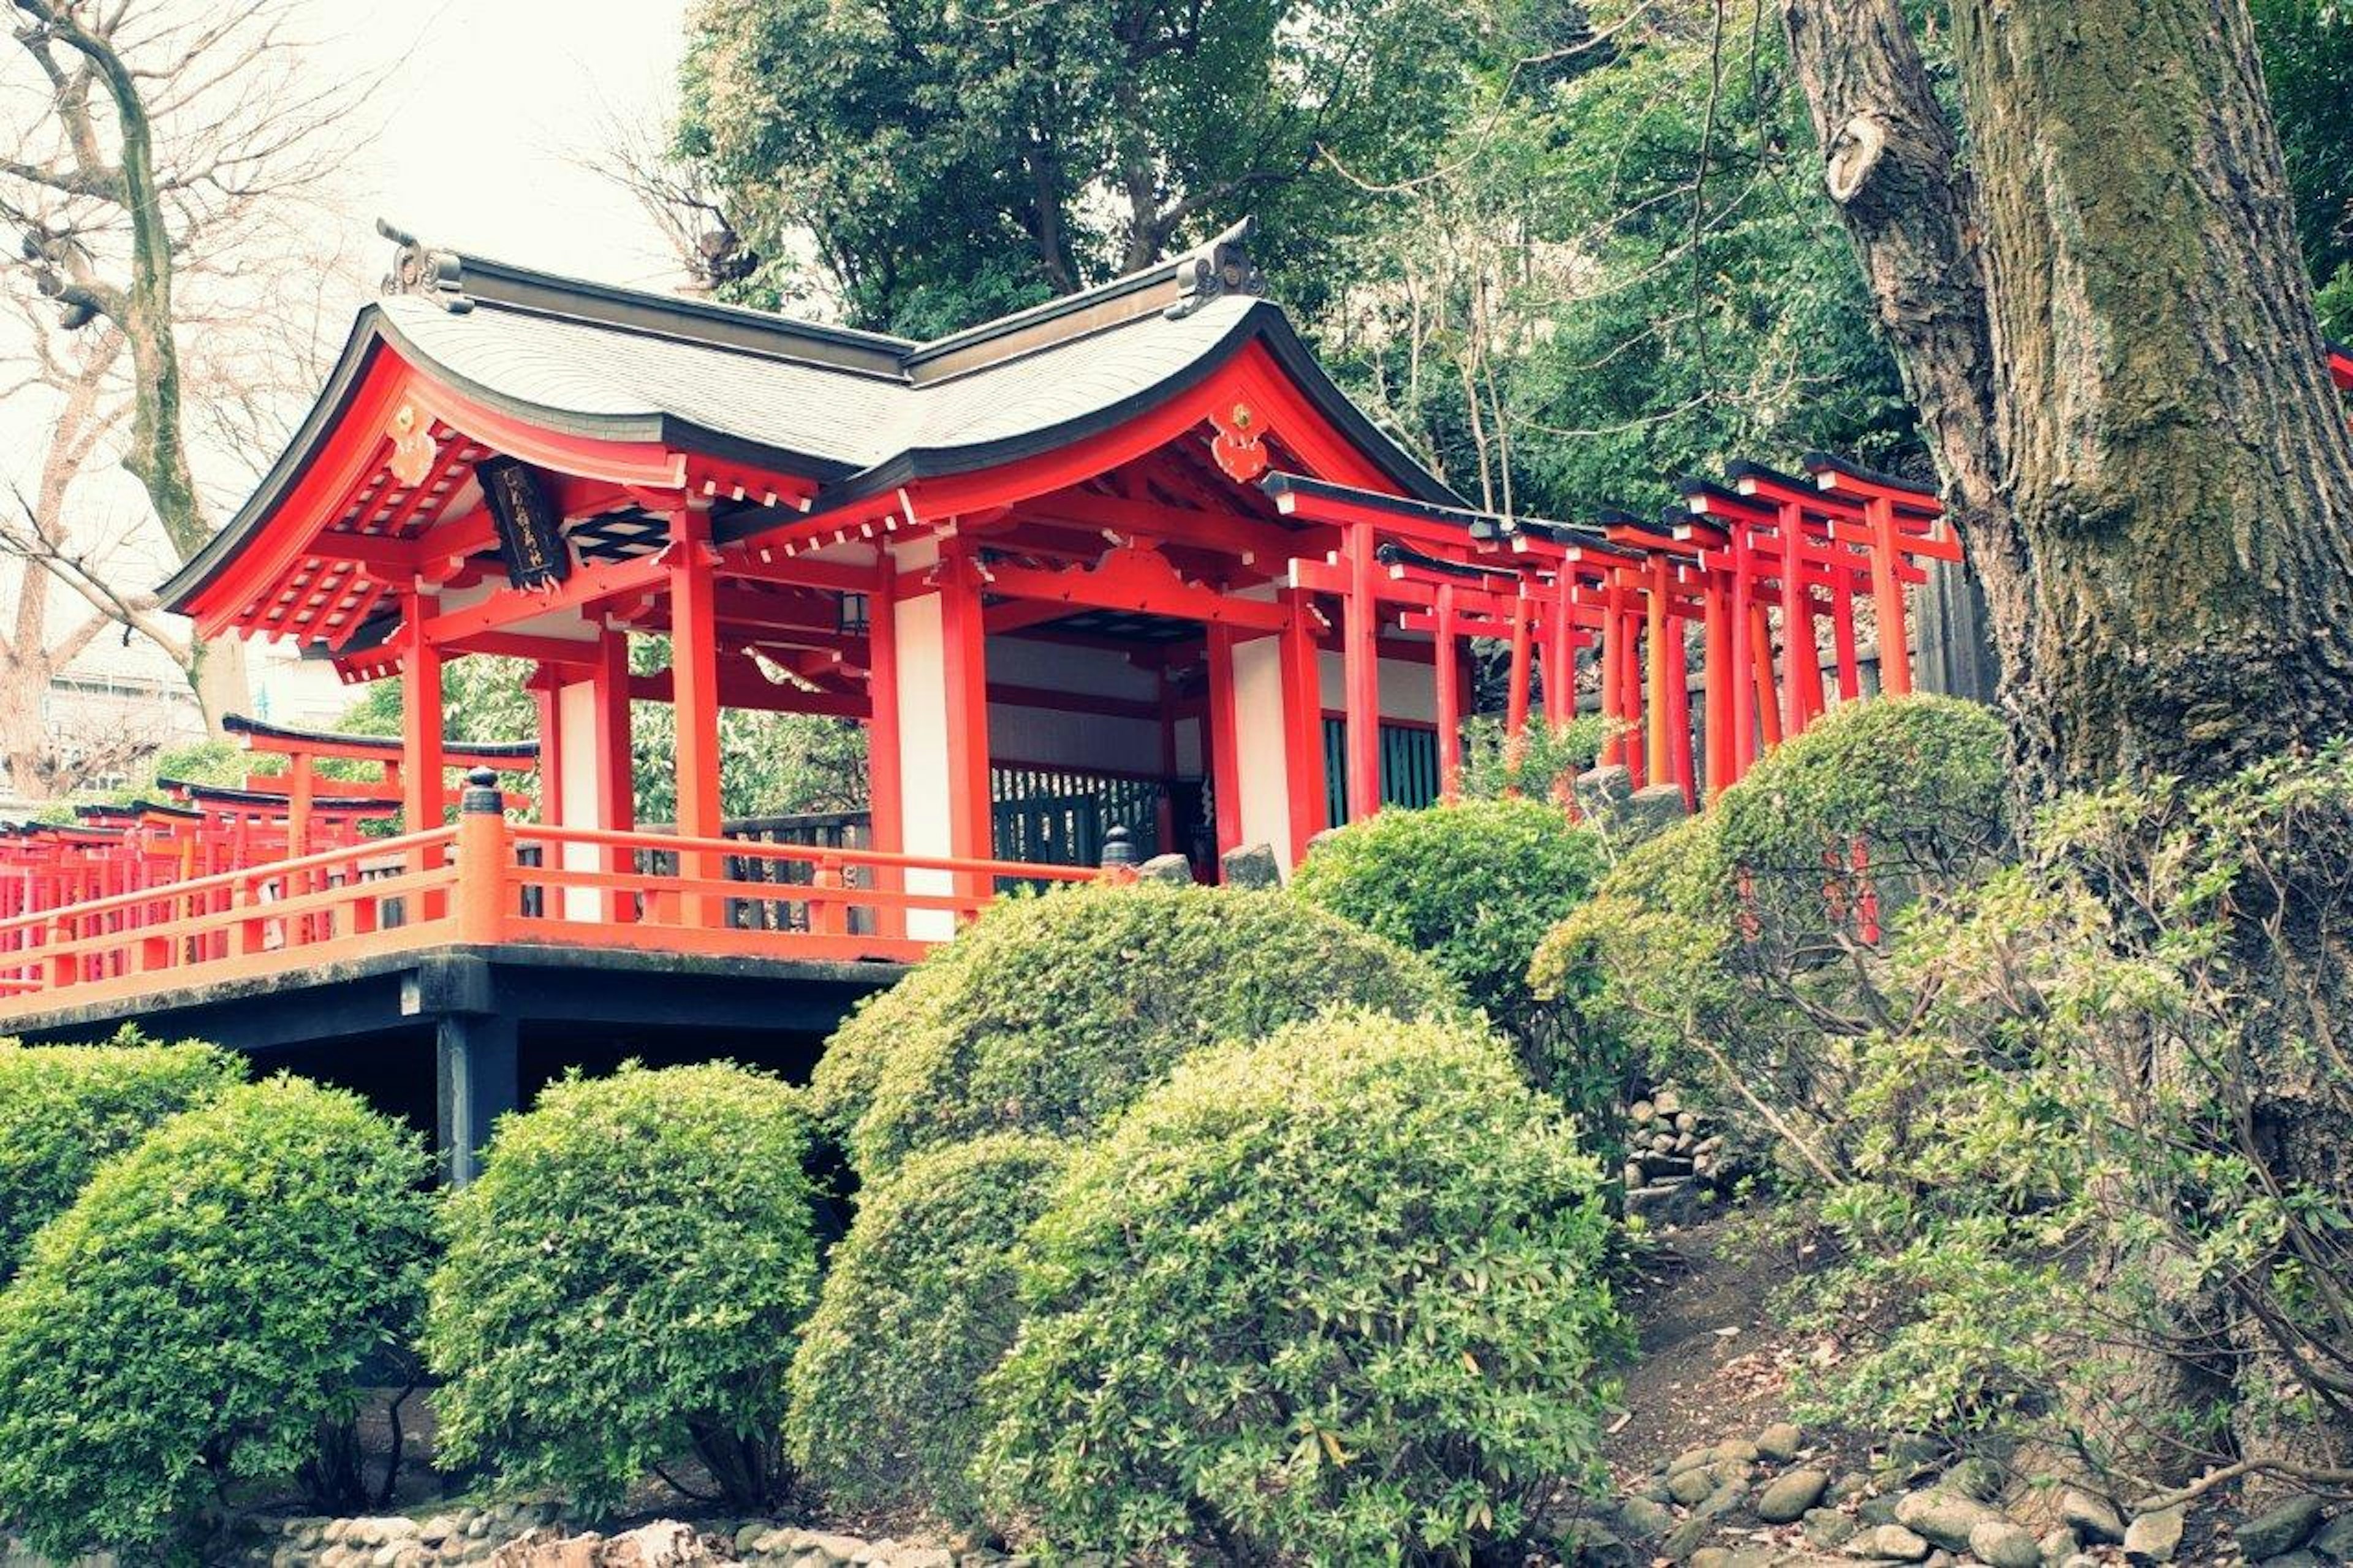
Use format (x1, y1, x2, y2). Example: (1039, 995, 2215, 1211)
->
(1268, 455, 1960, 805)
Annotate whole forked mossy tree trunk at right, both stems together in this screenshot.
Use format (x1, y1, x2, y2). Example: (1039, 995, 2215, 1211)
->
(1781, 0, 2353, 793)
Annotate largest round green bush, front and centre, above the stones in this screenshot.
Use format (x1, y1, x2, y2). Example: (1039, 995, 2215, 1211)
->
(981, 1012, 1616, 1563)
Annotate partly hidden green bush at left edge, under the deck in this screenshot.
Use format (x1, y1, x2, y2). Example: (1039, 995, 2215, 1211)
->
(0, 1031, 244, 1281)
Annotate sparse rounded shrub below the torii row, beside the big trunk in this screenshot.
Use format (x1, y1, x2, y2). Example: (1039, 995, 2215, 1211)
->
(1532, 697, 2009, 1172)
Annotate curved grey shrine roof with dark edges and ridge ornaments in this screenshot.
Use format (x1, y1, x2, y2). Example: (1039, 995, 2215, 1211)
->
(162, 231, 1459, 610)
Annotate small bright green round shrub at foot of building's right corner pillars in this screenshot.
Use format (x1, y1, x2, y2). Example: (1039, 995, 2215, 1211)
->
(1292, 798, 1602, 1038)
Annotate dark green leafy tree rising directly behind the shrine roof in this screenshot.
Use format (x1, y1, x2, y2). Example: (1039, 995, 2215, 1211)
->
(680, 0, 1492, 336)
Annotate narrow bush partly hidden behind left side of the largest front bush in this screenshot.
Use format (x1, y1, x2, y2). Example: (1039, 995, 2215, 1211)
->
(786, 1135, 1064, 1523)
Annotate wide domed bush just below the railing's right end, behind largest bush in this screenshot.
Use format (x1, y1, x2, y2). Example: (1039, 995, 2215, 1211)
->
(816, 883, 1459, 1182)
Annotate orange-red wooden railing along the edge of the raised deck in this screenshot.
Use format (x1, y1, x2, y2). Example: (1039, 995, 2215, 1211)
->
(0, 810, 1101, 1017)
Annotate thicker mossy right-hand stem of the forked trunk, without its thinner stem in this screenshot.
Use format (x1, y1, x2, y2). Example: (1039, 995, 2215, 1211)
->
(1953, 0, 2353, 786)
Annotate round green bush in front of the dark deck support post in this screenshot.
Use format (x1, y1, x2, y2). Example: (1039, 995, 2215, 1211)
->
(426, 1064, 816, 1509)
